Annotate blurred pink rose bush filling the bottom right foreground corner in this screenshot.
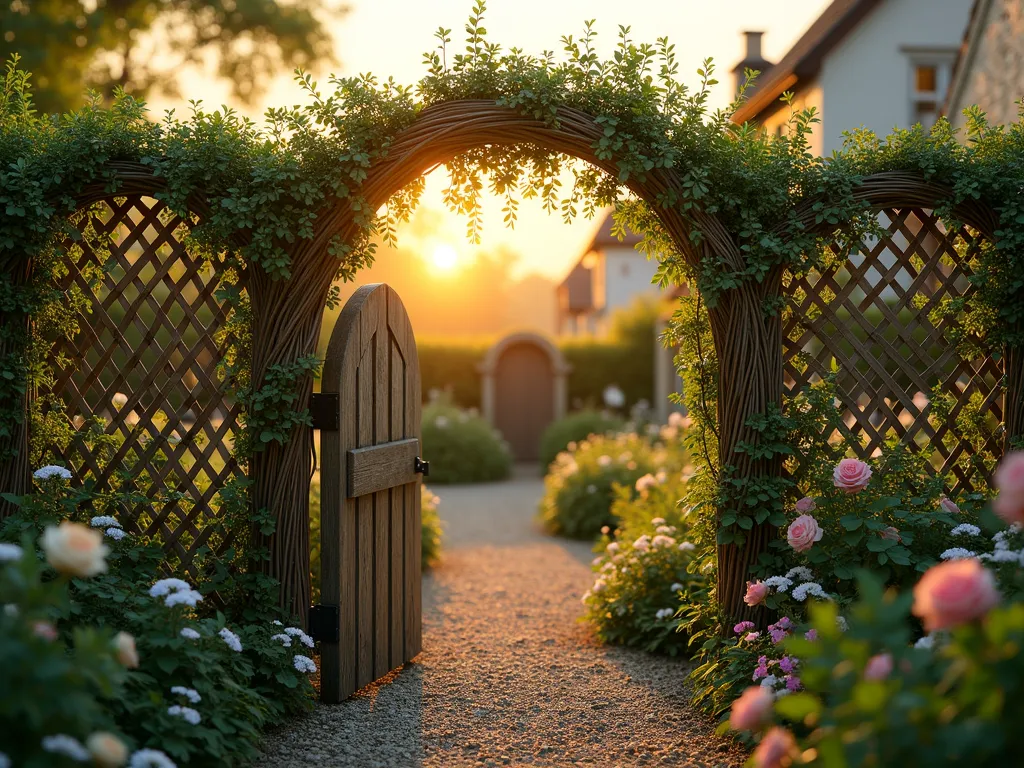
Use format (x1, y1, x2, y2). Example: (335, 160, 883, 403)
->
(734, 573, 1024, 768)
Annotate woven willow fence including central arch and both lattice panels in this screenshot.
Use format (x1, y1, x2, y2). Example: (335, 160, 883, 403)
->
(0, 100, 1022, 618)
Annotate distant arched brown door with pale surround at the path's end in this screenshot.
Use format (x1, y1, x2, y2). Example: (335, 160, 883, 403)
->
(479, 333, 569, 462)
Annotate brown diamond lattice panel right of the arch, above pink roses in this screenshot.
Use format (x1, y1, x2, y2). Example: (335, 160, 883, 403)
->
(783, 208, 1002, 489)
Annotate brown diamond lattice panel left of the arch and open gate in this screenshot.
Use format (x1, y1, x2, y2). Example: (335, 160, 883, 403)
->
(46, 196, 240, 569)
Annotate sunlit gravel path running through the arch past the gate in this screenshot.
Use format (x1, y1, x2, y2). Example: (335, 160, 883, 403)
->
(258, 469, 744, 768)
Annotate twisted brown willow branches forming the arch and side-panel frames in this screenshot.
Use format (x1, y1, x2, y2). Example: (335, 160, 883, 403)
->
(6, 99, 1022, 620)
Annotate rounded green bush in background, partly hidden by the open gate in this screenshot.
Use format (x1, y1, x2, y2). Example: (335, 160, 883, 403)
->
(422, 401, 512, 483)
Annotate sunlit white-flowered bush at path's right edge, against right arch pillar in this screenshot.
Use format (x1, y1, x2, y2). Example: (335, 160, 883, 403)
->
(583, 478, 707, 656)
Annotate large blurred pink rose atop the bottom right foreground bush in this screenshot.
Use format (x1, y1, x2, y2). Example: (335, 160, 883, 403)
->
(913, 558, 999, 632)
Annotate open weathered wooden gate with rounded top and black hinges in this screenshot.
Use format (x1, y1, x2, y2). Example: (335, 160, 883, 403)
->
(317, 284, 426, 702)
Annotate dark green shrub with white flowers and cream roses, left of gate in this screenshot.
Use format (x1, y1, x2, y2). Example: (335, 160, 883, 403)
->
(0, 474, 314, 766)
